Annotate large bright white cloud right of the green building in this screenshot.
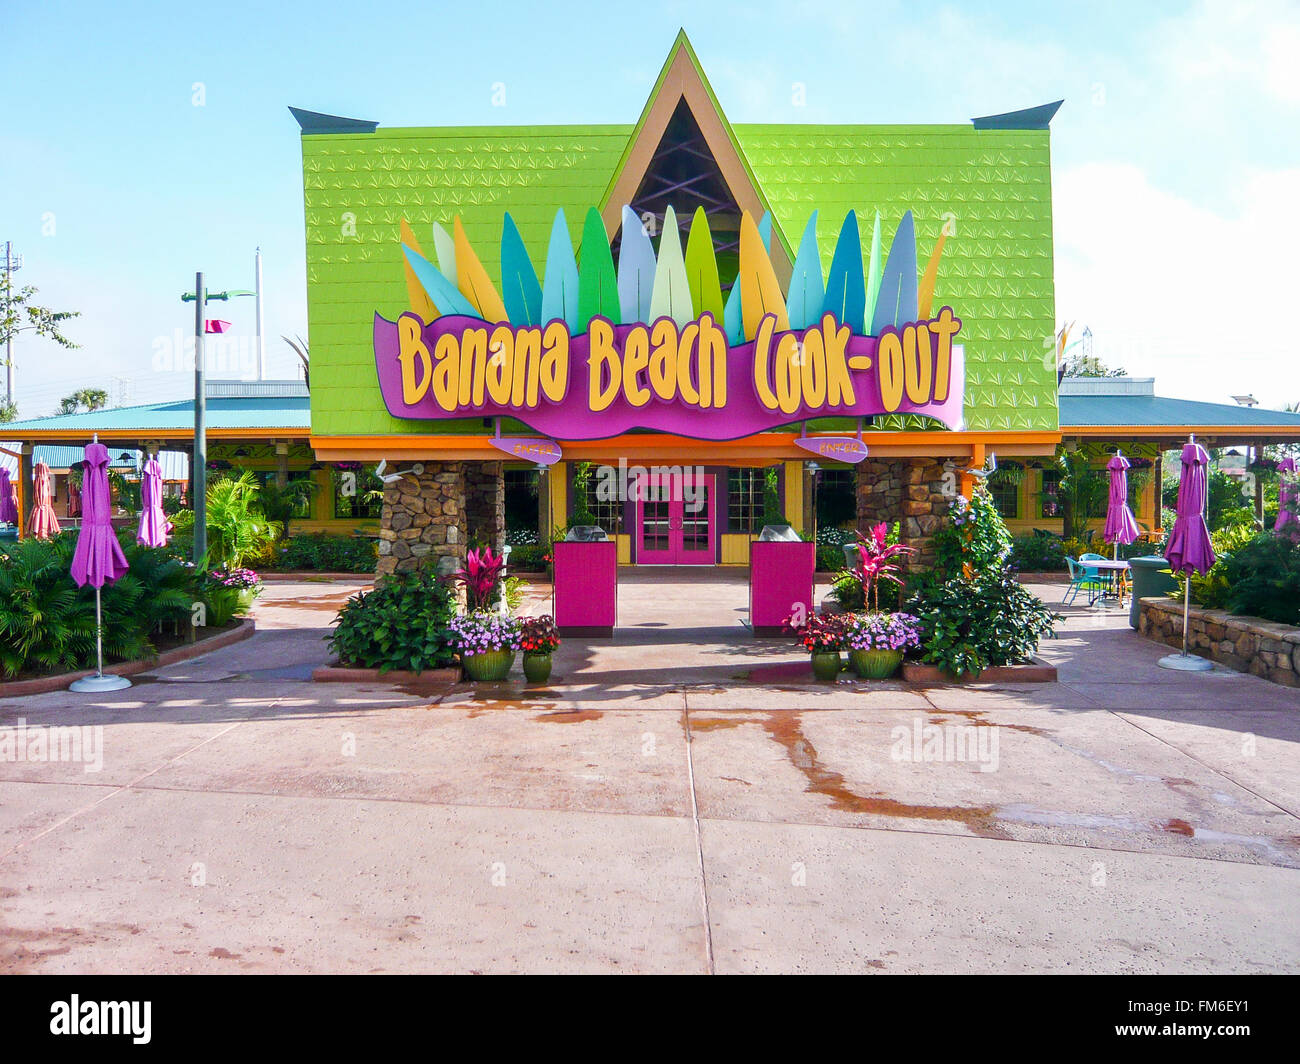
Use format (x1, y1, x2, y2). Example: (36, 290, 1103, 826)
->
(1053, 164, 1300, 407)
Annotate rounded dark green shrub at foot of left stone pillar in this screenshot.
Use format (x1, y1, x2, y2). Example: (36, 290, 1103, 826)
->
(329, 571, 456, 672)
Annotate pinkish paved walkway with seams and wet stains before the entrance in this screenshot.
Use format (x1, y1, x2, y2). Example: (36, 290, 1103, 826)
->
(0, 570, 1300, 972)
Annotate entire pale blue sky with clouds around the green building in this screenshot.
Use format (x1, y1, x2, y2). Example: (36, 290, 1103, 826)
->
(0, 0, 1300, 418)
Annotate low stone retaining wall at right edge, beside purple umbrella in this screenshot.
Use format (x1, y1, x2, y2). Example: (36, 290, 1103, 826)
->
(1138, 597, 1300, 687)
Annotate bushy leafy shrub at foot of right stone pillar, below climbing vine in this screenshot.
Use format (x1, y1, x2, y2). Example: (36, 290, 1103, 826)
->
(907, 570, 1056, 676)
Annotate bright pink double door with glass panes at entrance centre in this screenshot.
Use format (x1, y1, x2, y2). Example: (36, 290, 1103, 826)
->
(634, 473, 718, 566)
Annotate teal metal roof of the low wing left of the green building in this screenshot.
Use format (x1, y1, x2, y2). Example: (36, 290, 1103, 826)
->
(0, 395, 311, 437)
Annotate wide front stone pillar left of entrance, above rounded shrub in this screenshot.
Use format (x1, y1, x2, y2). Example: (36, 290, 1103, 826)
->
(376, 462, 467, 578)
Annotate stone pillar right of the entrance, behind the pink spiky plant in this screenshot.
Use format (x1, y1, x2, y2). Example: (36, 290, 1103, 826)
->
(858, 458, 956, 568)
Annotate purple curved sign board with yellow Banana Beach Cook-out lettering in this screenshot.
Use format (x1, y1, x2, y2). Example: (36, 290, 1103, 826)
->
(374, 307, 963, 439)
